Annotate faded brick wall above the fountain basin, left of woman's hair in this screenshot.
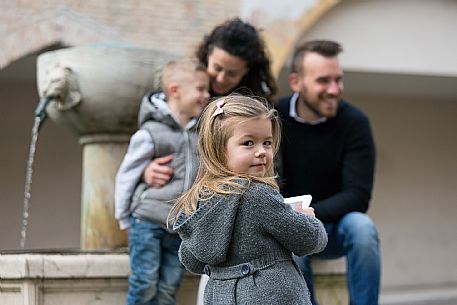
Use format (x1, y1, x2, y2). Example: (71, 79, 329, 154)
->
(0, 0, 239, 69)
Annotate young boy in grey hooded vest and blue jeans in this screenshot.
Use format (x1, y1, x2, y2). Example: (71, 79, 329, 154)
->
(115, 59, 209, 305)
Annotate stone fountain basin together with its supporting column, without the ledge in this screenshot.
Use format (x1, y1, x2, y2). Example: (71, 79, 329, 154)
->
(37, 45, 175, 249)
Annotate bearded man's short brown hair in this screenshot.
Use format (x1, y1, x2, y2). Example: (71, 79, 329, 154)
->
(291, 40, 343, 74)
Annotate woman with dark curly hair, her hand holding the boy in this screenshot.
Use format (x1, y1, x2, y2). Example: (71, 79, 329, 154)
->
(143, 18, 277, 187)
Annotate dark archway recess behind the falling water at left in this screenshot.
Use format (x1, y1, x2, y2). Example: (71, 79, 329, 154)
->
(0, 43, 82, 250)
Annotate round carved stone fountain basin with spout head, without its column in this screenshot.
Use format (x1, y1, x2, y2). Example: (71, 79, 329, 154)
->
(37, 45, 172, 135)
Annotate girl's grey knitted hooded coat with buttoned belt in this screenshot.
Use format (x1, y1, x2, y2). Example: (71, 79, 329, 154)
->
(174, 182, 327, 305)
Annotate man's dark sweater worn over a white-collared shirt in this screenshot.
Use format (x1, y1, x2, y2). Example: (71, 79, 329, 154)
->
(276, 97, 375, 223)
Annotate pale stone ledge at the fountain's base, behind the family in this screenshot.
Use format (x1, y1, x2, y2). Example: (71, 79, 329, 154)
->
(0, 252, 344, 305)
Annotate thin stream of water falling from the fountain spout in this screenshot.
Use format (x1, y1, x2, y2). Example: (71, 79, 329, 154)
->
(20, 116, 42, 249)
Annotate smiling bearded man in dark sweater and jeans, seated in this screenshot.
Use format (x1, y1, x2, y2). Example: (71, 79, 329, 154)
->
(277, 40, 381, 305)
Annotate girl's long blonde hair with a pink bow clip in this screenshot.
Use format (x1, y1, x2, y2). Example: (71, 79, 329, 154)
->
(170, 94, 281, 218)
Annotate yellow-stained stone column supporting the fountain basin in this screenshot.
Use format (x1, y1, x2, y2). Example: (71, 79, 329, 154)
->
(79, 134, 129, 249)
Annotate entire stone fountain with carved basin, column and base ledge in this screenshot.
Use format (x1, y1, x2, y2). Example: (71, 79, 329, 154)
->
(0, 45, 198, 305)
